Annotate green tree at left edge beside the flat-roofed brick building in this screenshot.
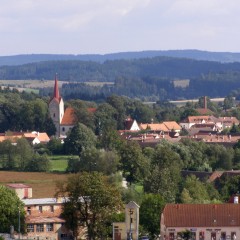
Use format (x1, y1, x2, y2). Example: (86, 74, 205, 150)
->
(0, 185, 25, 233)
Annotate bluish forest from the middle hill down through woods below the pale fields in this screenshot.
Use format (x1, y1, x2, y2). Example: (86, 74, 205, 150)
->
(0, 57, 240, 101)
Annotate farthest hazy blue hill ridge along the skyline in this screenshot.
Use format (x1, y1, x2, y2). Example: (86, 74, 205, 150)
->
(0, 50, 240, 66)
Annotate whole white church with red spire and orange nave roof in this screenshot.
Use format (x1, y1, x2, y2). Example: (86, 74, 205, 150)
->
(48, 74, 77, 139)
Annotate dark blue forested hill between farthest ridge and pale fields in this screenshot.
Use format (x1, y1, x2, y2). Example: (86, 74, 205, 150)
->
(0, 57, 240, 82)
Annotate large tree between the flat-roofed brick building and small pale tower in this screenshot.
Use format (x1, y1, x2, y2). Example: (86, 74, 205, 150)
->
(57, 172, 122, 240)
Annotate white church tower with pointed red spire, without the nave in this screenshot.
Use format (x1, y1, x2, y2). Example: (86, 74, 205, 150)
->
(49, 74, 64, 137)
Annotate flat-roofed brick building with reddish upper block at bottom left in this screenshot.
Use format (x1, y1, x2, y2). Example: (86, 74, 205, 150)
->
(6, 183, 71, 240)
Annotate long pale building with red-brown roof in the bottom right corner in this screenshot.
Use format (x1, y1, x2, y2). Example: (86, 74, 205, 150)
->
(160, 202, 240, 240)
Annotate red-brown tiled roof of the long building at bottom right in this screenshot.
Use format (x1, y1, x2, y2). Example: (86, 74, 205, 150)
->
(162, 203, 240, 227)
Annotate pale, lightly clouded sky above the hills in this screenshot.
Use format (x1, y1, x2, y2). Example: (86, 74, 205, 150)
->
(0, 0, 240, 56)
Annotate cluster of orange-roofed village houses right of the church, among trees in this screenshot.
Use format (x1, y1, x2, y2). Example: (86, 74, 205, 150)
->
(119, 115, 240, 146)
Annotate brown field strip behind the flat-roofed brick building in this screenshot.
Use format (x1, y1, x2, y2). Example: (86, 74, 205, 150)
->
(0, 171, 69, 198)
